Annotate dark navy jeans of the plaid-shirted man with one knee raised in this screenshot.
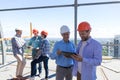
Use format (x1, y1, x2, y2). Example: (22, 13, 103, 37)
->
(31, 55, 49, 78)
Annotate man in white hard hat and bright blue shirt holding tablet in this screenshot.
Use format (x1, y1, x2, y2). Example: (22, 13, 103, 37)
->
(50, 25, 75, 80)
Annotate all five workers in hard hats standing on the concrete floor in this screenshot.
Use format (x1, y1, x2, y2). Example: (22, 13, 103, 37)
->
(11, 21, 102, 80)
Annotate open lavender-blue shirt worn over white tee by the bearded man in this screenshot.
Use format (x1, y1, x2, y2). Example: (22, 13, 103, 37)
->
(73, 38, 102, 80)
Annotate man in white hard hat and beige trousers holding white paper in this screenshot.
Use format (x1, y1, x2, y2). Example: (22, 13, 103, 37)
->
(11, 28, 26, 79)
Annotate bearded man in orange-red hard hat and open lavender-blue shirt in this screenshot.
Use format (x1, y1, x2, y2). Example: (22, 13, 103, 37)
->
(71, 21, 102, 80)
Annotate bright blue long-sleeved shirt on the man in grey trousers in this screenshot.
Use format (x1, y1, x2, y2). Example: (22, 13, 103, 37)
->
(50, 40, 75, 67)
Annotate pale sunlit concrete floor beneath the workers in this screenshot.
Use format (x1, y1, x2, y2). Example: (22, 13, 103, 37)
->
(0, 55, 120, 80)
